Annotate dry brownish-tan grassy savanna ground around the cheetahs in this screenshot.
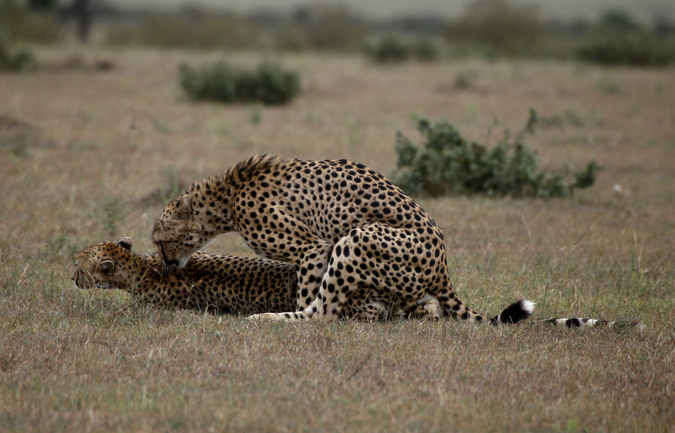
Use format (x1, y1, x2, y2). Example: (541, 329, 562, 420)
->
(0, 50, 675, 432)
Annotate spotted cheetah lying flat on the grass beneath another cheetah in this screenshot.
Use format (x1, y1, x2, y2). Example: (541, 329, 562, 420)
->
(71, 237, 434, 321)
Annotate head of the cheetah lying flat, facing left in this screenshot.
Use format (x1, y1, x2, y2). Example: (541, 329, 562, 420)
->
(71, 238, 134, 289)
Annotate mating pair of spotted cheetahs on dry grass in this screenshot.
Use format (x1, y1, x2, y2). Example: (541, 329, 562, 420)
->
(73, 156, 616, 326)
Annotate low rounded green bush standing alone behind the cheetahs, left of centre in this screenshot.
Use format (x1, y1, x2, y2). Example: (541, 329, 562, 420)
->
(180, 60, 300, 105)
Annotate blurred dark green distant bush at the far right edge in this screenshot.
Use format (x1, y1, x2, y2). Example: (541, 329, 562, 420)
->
(577, 30, 675, 66)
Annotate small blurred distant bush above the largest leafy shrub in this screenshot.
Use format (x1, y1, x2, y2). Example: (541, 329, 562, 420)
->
(365, 36, 440, 63)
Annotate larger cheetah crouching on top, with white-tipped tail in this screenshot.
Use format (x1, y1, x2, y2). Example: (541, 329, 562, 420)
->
(152, 155, 534, 324)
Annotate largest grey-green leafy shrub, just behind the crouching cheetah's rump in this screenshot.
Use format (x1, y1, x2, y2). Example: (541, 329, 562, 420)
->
(393, 110, 599, 198)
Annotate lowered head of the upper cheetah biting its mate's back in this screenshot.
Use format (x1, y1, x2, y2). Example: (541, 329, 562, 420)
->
(152, 194, 213, 275)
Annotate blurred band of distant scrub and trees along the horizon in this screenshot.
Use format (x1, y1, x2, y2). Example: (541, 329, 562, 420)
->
(0, 0, 675, 66)
